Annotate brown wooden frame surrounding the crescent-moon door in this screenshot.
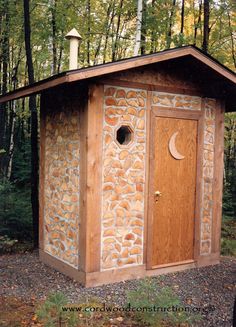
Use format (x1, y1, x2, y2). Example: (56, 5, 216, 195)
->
(146, 106, 204, 270)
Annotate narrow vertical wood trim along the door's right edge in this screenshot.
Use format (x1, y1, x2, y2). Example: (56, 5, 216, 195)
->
(193, 99, 205, 260)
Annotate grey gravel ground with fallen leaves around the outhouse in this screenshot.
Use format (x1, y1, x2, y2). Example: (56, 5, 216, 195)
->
(0, 252, 236, 327)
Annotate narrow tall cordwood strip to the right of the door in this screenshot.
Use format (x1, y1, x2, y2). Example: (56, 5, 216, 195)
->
(200, 99, 216, 255)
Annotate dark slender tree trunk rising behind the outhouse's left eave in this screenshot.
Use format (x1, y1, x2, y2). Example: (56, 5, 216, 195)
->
(24, 0, 39, 247)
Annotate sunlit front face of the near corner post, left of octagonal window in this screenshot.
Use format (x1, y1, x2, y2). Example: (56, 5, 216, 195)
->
(85, 84, 104, 272)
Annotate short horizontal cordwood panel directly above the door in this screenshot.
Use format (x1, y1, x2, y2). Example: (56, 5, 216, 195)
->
(152, 92, 201, 110)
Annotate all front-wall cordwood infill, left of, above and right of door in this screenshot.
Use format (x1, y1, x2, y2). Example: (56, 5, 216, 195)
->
(101, 86, 216, 269)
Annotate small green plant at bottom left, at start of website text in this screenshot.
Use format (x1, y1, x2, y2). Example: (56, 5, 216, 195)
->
(36, 292, 78, 327)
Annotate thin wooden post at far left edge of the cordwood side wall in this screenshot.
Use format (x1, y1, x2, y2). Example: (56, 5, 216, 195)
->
(39, 94, 46, 250)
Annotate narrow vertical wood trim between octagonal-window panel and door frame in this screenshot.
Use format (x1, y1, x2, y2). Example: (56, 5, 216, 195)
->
(143, 91, 152, 263)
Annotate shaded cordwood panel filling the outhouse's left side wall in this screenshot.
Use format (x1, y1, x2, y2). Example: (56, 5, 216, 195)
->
(44, 108, 79, 267)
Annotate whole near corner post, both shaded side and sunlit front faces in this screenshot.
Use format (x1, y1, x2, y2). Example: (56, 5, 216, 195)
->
(79, 84, 103, 272)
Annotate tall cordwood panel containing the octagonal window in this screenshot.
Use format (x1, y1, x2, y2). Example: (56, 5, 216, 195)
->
(101, 86, 147, 270)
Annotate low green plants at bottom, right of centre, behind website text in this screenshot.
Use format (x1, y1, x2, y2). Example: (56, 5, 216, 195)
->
(127, 278, 200, 326)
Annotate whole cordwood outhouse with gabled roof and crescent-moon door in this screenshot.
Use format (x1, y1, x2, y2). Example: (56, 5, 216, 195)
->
(0, 46, 236, 286)
